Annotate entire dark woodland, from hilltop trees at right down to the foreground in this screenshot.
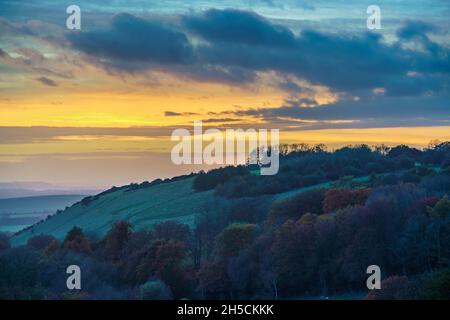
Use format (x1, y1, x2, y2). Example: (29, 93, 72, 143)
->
(0, 142, 450, 299)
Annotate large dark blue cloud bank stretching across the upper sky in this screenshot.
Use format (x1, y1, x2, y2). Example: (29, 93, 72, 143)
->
(61, 9, 450, 96)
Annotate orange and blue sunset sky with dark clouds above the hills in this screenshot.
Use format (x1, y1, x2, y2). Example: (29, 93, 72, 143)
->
(0, 0, 450, 187)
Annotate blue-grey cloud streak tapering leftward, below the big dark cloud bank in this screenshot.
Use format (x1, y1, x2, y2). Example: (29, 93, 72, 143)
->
(223, 96, 450, 128)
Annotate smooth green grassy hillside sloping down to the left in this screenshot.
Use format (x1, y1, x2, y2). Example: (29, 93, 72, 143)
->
(11, 178, 212, 245)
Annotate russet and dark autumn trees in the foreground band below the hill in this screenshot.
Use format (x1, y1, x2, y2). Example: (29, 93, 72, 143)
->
(0, 188, 450, 299)
